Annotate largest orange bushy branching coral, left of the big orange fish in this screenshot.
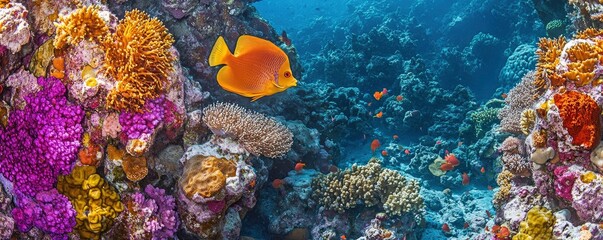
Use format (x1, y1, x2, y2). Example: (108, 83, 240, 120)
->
(103, 10, 175, 112)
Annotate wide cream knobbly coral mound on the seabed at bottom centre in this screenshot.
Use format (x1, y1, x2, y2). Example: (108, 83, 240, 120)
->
(312, 158, 423, 215)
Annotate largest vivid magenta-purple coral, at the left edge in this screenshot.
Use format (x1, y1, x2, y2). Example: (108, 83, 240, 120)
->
(0, 77, 84, 196)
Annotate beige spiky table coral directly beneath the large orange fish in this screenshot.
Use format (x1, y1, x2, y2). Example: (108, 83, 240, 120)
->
(203, 102, 293, 158)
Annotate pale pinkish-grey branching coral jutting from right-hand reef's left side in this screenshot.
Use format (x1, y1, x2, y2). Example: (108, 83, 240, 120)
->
(498, 71, 535, 134)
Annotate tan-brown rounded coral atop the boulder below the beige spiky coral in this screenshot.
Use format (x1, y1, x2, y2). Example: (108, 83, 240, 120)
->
(180, 155, 237, 198)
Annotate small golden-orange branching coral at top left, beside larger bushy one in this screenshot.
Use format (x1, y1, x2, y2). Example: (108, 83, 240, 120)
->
(54, 6, 109, 49)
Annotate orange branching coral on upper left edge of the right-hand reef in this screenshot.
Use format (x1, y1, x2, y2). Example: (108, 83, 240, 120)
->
(534, 36, 566, 97)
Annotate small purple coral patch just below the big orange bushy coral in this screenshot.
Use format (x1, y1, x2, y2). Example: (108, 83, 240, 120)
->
(119, 97, 166, 140)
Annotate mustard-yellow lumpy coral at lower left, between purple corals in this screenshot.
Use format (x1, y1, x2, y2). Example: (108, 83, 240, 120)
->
(57, 166, 124, 239)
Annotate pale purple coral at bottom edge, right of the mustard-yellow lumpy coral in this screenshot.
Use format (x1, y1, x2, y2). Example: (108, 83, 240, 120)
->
(126, 185, 179, 239)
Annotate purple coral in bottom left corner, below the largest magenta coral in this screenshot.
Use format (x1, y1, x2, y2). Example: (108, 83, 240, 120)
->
(12, 189, 76, 239)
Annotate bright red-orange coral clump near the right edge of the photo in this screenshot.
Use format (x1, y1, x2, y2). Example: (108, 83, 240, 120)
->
(553, 91, 601, 150)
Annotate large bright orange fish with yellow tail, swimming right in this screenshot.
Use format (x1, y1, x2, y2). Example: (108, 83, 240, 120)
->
(209, 35, 297, 101)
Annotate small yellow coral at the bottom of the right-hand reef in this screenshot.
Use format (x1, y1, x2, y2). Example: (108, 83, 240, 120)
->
(513, 206, 556, 240)
